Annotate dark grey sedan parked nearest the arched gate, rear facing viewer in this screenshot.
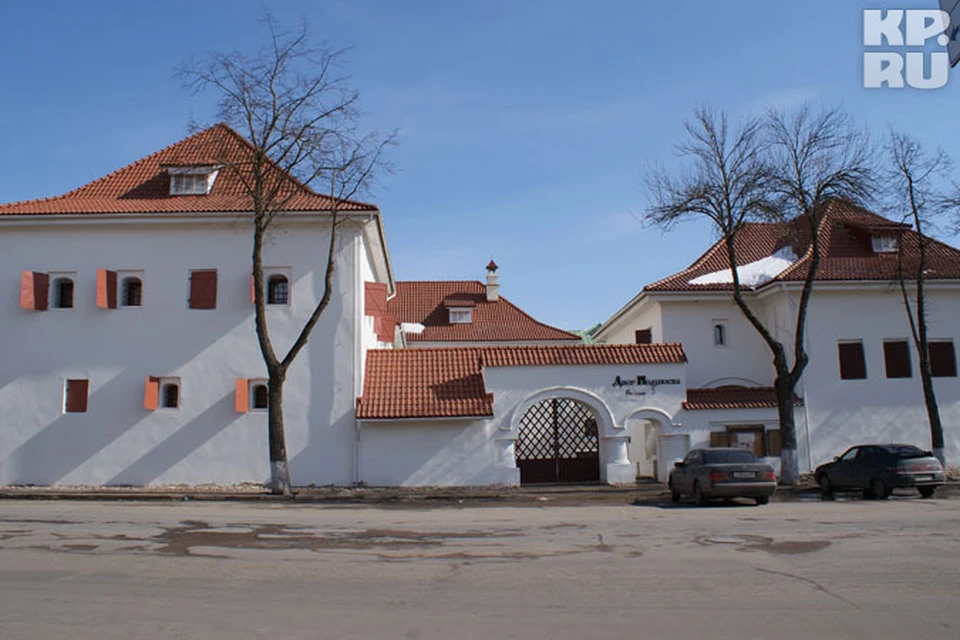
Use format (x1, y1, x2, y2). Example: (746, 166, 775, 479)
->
(667, 447, 777, 505)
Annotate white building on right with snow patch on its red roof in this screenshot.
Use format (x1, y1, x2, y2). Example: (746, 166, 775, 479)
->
(595, 201, 960, 473)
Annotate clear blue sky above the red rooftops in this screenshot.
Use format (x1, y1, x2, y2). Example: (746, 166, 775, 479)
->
(0, 0, 960, 328)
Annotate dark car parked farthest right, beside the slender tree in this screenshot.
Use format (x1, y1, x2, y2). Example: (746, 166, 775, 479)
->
(814, 444, 947, 500)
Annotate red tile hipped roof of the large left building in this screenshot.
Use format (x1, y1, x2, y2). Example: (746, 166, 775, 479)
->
(0, 124, 376, 215)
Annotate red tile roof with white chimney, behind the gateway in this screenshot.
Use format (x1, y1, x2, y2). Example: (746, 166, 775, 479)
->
(387, 280, 582, 344)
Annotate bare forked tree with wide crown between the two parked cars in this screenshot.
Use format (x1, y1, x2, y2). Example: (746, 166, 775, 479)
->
(646, 106, 874, 484)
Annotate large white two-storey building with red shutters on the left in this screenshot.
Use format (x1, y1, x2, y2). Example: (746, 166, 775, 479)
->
(0, 125, 395, 485)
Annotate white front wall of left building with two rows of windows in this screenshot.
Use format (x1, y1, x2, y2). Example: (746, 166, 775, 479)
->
(0, 221, 378, 485)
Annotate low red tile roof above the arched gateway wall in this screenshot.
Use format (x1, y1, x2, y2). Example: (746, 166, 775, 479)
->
(357, 344, 686, 420)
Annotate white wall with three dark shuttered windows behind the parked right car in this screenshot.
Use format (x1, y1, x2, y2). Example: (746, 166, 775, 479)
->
(800, 287, 960, 466)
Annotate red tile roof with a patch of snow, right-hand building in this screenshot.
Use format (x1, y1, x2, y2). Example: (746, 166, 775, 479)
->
(644, 200, 960, 292)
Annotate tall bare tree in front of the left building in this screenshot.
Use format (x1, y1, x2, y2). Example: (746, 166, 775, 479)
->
(178, 15, 395, 494)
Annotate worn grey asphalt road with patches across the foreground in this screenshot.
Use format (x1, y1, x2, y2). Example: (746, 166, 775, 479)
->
(0, 497, 960, 640)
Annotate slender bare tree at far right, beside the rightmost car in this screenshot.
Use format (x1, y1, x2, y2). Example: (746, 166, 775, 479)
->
(885, 131, 952, 464)
